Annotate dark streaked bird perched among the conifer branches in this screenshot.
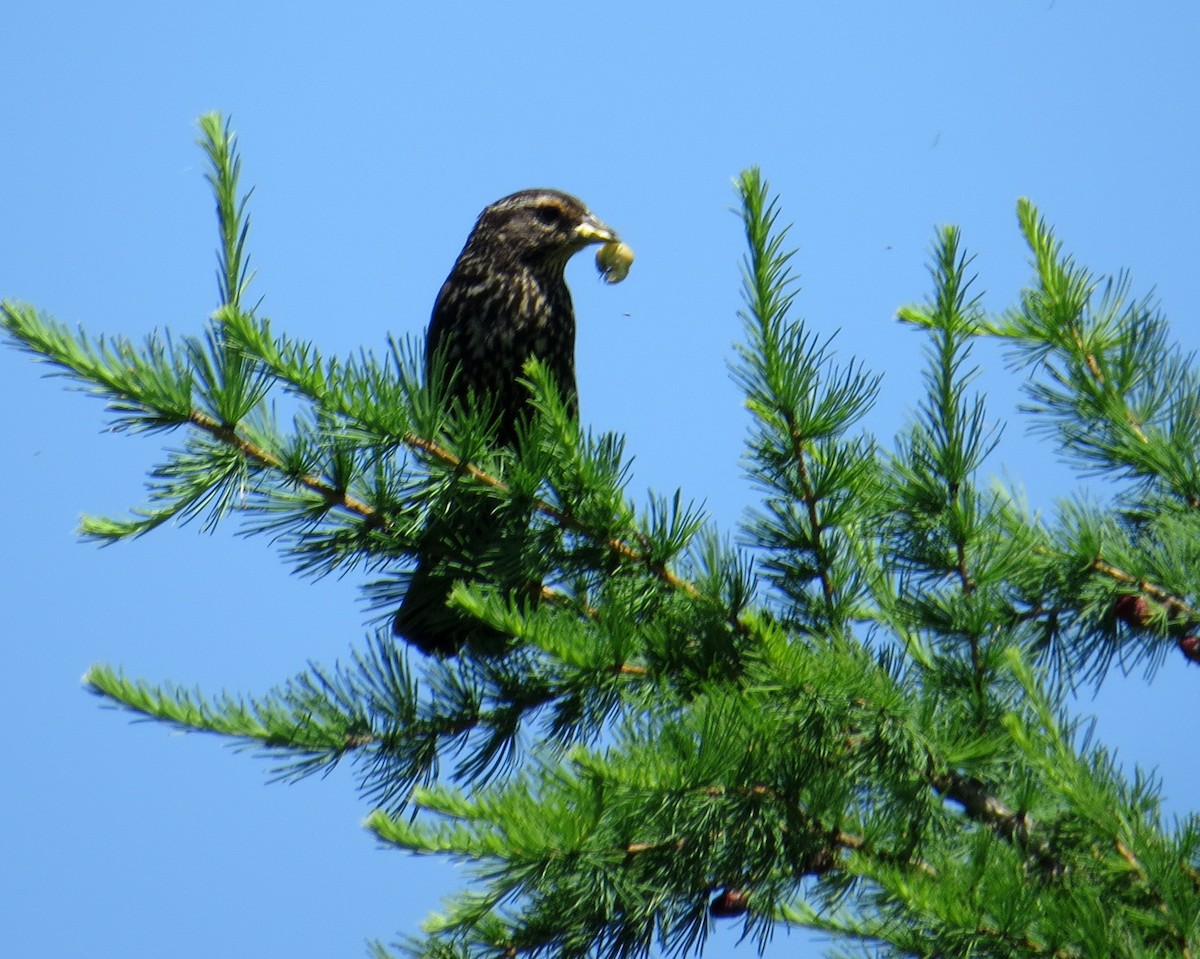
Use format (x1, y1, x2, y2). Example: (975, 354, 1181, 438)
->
(392, 188, 620, 657)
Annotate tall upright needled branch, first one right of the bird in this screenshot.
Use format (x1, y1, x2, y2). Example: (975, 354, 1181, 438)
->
(733, 169, 878, 631)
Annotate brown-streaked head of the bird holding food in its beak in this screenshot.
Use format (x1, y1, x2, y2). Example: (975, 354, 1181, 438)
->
(467, 190, 619, 270)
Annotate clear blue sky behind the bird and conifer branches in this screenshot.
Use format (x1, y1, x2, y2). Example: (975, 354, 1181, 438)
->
(0, 0, 1200, 959)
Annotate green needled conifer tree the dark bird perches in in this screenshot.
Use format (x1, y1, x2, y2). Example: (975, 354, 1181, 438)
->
(2, 115, 1200, 959)
